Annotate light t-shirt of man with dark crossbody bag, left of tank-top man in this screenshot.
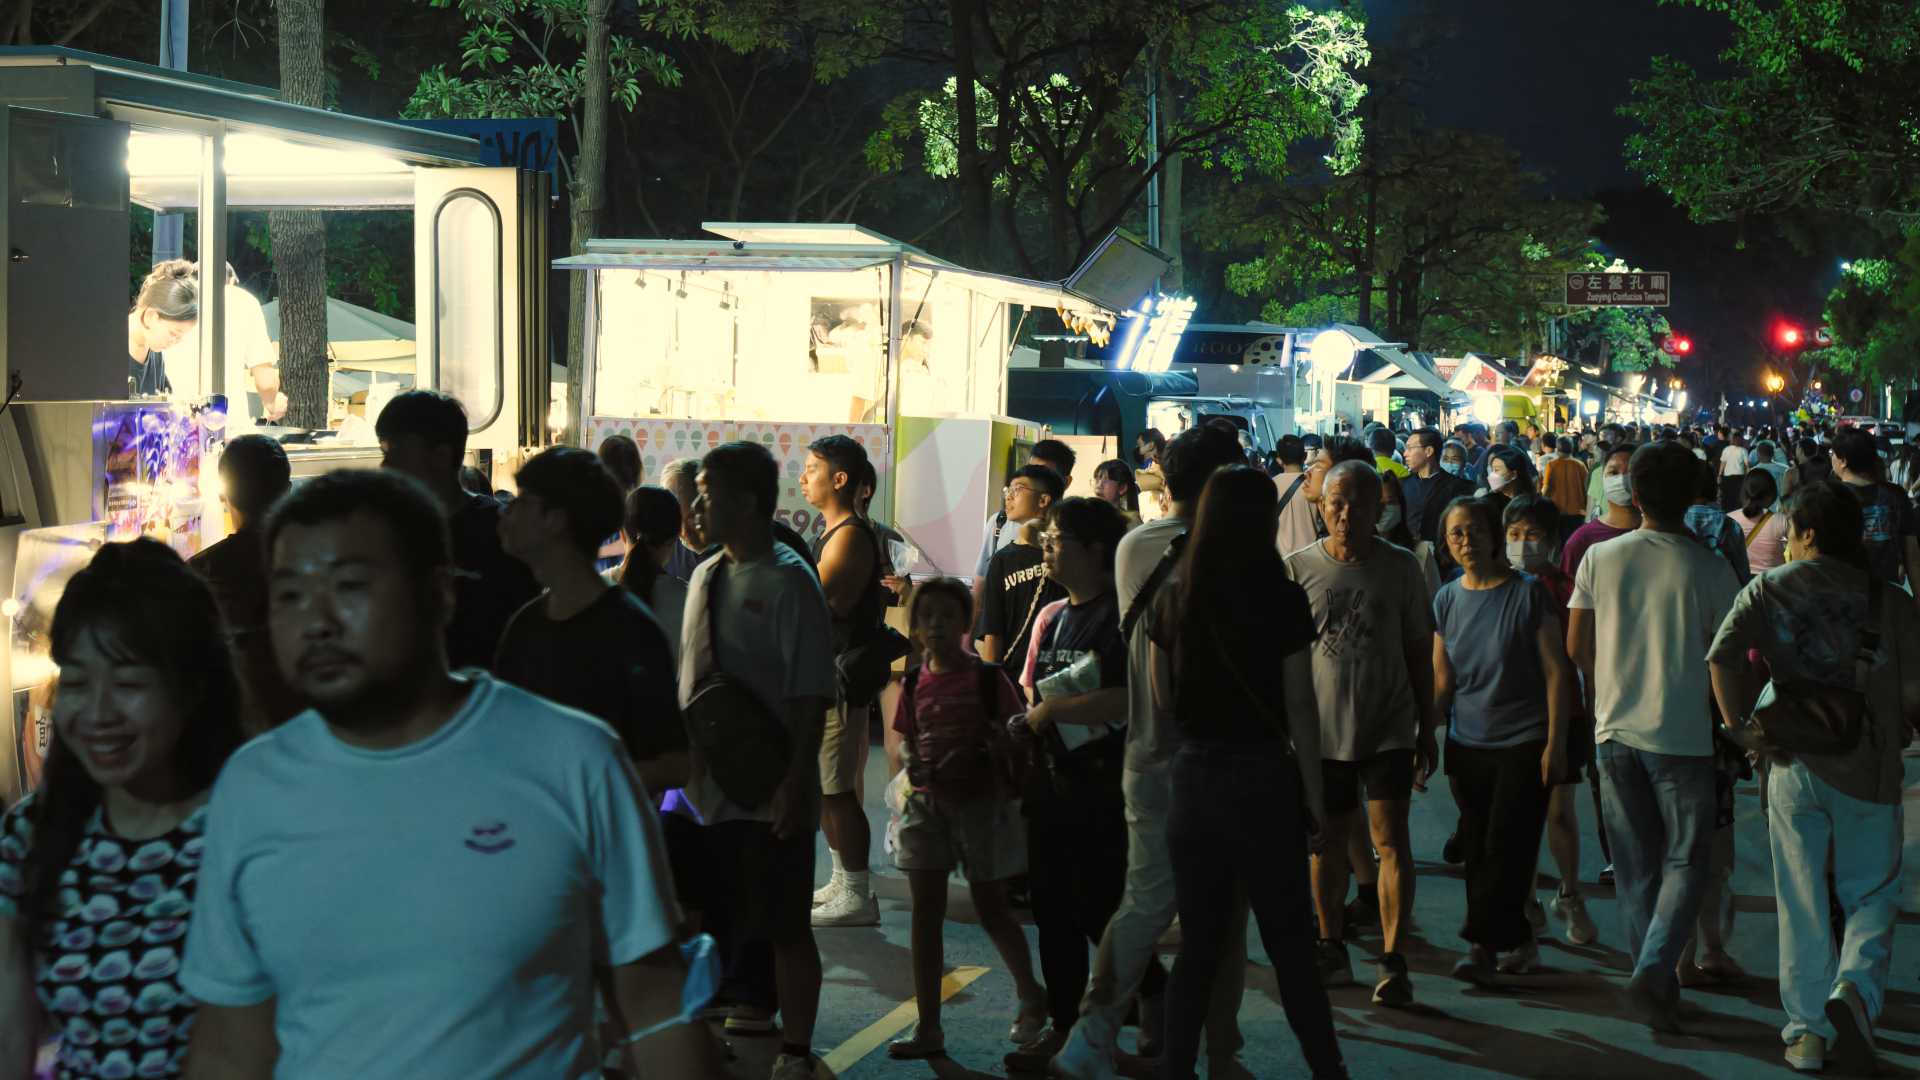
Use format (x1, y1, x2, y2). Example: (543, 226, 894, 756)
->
(680, 544, 839, 824)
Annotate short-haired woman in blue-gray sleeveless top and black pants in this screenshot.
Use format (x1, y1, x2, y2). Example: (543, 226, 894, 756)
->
(1434, 500, 1574, 982)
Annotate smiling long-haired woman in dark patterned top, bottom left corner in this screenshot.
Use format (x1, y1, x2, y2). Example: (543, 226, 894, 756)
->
(0, 540, 240, 1080)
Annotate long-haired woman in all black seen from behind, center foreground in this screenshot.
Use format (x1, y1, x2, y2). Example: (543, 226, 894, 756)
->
(1148, 465, 1346, 1080)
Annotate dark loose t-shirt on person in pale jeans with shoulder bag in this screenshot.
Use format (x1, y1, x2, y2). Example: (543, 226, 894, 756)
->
(1707, 559, 1920, 805)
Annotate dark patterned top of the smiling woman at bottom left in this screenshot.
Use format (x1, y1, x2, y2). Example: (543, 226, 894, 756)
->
(0, 796, 207, 1080)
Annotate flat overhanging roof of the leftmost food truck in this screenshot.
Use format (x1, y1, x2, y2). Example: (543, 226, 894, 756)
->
(0, 46, 484, 165)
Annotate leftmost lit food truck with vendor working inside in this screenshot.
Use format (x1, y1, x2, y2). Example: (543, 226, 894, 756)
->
(0, 48, 549, 801)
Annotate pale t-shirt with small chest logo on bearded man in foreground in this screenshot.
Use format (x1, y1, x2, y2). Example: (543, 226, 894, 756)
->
(180, 673, 680, 1080)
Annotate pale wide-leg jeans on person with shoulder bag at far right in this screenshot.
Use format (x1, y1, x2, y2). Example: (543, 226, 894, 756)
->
(1766, 761, 1905, 1043)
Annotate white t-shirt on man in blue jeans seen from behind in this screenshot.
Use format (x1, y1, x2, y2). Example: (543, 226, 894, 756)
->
(1569, 528, 1740, 757)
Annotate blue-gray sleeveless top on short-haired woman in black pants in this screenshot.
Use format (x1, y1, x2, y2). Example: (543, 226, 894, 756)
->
(1434, 575, 1553, 749)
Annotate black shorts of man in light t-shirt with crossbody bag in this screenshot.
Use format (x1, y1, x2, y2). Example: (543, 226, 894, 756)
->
(699, 821, 814, 945)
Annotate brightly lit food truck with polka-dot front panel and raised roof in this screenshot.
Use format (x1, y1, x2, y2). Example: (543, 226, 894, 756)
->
(553, 223, 1117, 577)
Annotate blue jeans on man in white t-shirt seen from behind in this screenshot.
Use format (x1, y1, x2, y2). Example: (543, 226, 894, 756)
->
(1596, 742, 1715, 999)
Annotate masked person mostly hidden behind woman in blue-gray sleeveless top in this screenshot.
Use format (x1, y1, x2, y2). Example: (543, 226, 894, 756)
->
(1501, 496, 1607, 945)
